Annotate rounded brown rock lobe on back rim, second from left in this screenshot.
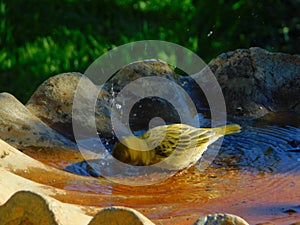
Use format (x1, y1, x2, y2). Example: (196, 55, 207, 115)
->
(26, 73, 111, 140)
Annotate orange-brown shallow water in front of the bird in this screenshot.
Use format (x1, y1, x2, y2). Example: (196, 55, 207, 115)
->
(22, 148, 300, 224)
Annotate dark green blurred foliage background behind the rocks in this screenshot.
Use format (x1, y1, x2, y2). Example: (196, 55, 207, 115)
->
(0, 0, 300, 103)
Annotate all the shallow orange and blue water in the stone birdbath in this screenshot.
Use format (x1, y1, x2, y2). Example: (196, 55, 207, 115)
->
(21, 113, 300, 224)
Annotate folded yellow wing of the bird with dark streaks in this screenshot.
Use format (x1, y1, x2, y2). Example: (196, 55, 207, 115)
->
(145, 124, 216, 157)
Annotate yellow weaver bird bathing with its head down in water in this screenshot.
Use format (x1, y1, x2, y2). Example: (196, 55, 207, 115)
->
(112, 124, 241, 170)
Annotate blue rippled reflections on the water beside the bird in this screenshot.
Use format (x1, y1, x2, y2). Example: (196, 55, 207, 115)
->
(65, 111, 300, 176)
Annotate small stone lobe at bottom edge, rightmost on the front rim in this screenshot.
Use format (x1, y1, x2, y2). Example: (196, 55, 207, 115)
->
(194, 214, 249, 225)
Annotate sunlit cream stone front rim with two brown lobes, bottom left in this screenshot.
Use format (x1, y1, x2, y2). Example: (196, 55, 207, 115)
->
(0, 139, 153, 225)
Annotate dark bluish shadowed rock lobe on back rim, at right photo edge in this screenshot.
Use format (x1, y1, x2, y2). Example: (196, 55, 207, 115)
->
(250, 48, 300, 112)
